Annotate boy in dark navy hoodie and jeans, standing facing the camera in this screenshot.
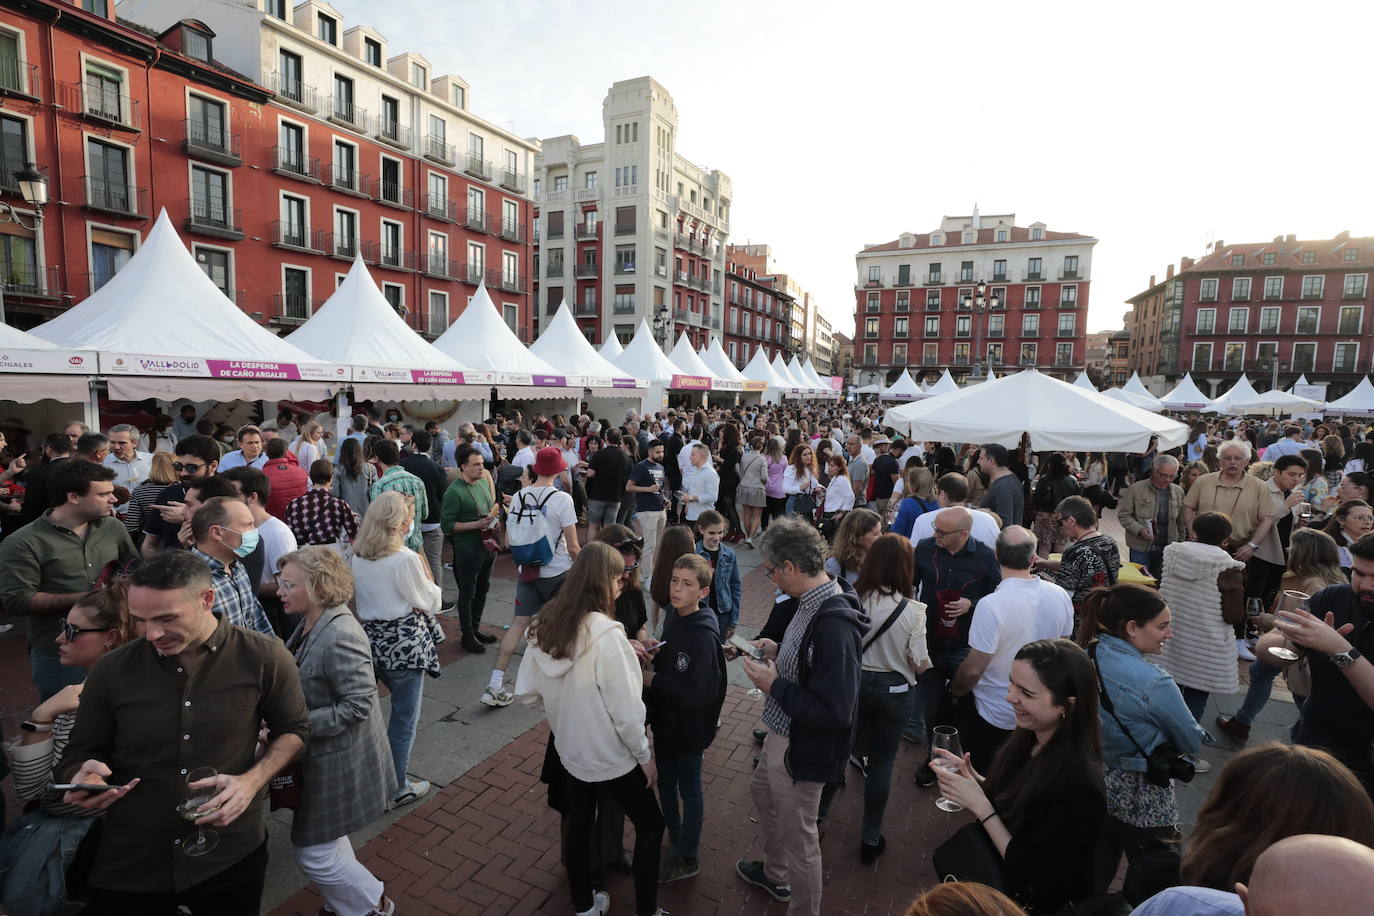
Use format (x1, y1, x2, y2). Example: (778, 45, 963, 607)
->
(644, 554, 730, 883)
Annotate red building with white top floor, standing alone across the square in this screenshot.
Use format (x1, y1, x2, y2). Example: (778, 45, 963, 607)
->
(853, 210, 1098, 385)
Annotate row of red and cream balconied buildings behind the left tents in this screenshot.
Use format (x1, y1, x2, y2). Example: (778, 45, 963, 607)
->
(0, 0, 534, 339)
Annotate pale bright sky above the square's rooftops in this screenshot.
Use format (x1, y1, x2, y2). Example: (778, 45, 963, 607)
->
(359, 0, 1374, 339)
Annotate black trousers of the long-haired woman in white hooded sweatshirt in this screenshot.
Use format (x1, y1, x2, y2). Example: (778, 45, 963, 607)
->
(566, 766, 664, 913)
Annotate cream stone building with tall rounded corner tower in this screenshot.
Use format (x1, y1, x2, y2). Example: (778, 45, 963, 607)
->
(533, 77, 732, 343)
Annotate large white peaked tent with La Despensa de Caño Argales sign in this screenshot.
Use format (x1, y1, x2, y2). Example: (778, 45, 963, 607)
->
(33, 210, 335, 401)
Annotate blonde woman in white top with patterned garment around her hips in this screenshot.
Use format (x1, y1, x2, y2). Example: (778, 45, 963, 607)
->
(352, 490, 444, 808)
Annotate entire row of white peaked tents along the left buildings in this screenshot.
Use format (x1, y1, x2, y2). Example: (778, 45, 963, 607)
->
(0, 211, 831, 402)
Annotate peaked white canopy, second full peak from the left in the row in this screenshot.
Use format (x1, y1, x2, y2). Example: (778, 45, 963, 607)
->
(286, 257, 477, 380)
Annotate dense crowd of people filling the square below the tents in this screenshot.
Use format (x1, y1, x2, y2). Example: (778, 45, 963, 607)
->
(0, 404, 1374, 916)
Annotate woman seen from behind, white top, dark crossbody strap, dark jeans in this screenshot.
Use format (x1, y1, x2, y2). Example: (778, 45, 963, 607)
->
(851, 534, 930, 865)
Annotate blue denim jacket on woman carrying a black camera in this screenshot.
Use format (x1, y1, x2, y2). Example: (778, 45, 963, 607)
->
(1096, 634, 1204, 773)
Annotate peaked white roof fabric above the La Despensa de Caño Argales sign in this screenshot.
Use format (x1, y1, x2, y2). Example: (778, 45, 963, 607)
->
(33, 210, 318, 364)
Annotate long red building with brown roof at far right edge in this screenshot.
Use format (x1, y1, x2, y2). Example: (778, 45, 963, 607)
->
(1128, 232, 1374, 398)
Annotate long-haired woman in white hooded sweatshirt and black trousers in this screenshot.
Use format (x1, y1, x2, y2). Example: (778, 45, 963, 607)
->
(515, 541, 664, 916)
